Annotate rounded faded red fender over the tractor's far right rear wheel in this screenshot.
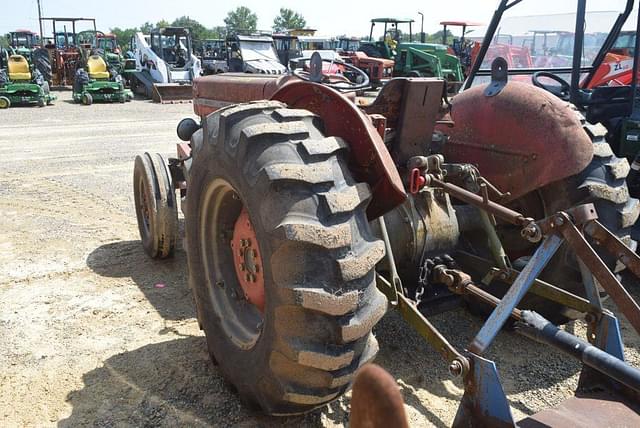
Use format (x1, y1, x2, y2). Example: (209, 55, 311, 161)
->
(438, 81, 593, 200)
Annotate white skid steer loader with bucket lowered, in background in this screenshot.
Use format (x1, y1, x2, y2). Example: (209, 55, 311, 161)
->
(130, 27, 202, 103)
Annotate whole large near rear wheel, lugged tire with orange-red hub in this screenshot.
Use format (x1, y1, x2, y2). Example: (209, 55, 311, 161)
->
(185, 101, 387, 415)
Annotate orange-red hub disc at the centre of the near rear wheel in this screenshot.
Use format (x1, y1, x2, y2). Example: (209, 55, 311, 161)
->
(231, 207, 265, 312)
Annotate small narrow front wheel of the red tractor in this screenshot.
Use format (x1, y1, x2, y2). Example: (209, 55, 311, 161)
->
(133, 153, 178, 259)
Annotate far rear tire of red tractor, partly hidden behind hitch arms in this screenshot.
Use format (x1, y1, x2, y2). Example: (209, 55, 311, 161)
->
(498, 125, 640, 324)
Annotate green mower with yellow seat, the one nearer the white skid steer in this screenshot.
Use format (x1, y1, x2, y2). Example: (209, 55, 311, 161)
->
(73, 55, 133, 105)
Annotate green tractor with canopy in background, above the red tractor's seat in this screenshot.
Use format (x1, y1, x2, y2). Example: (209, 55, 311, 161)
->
(360, 18, 464, 91)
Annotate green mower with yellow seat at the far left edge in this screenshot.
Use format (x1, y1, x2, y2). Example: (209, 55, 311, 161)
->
(0, 53, 56, 109)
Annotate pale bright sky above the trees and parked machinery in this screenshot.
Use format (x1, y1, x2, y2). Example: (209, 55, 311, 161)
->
(0, 0, 624, 37)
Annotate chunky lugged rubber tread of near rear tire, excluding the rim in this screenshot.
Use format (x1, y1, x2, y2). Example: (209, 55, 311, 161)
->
(187, 101, 387, 415)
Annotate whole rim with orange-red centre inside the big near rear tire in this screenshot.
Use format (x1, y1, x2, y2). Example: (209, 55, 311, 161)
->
(199, 179, 265, 350)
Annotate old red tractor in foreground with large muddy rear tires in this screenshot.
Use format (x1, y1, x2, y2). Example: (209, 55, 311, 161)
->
(134, 0, 640, 426)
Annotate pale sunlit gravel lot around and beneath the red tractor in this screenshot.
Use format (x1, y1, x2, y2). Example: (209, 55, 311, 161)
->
(0, 92, 640, 427)
